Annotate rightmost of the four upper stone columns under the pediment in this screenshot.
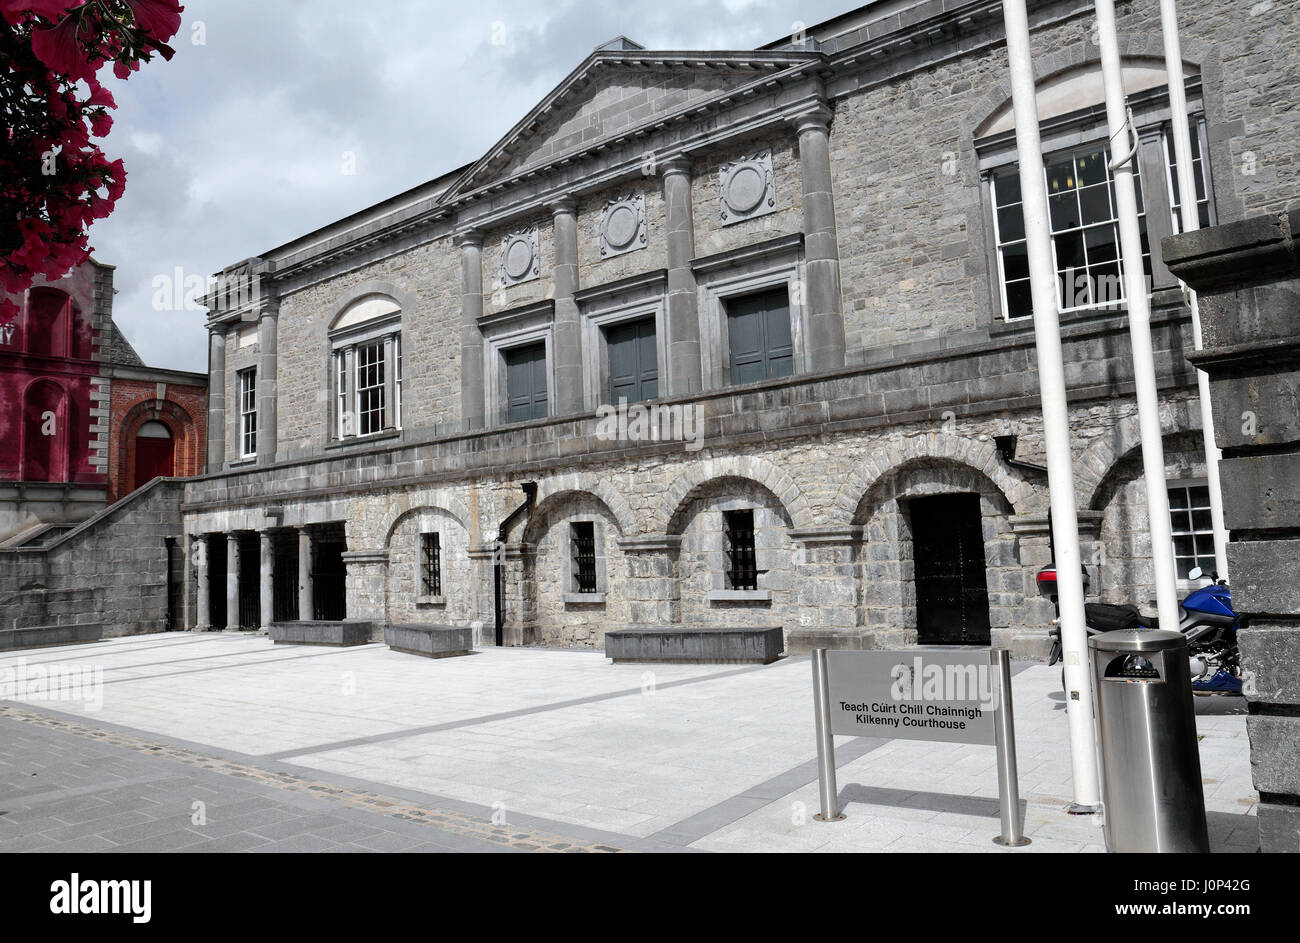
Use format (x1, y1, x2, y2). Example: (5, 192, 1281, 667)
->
(793, 105, 844, 372)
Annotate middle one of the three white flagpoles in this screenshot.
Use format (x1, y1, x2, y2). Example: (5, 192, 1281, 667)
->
(1096, 0, 1179, 632)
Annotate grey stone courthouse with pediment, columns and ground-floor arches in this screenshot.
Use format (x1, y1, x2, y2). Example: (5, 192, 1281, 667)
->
(182, 0, 1300, 653)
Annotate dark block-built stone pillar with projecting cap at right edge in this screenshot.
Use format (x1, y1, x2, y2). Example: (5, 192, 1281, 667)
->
(1162, 208, 1300, 853)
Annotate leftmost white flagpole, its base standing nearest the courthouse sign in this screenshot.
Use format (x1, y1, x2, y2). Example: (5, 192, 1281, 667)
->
(1002, 0, 1100, 813)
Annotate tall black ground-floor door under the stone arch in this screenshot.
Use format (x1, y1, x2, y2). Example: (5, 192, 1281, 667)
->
(910, 494, 991, 645)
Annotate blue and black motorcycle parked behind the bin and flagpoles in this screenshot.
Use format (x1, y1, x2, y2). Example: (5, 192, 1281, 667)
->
(1037, 564, 1242, 696)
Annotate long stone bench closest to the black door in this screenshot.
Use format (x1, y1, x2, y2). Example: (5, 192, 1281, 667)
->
(605, 626, 785, 665)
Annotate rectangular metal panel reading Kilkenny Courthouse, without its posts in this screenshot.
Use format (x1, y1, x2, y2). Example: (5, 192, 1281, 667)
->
(827, 649, 1000, 747)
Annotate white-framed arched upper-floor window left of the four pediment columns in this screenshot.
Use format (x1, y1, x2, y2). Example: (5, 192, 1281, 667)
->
(329, 294, 402, 440)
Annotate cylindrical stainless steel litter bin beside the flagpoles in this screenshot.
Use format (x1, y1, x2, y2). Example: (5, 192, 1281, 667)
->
(1088, 628, 1210, 852)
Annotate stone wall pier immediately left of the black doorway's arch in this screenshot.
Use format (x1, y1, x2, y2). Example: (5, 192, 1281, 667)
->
(785, 525, 872, 654)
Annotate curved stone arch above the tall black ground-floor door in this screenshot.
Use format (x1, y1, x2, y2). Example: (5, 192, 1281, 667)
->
(832, 432, 1045, 524)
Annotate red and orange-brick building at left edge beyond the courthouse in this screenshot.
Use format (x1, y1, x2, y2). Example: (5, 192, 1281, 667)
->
(0, 260, 207, 546)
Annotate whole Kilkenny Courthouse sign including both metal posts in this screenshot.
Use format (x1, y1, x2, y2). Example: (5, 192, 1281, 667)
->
(813, 649, 1030, 847)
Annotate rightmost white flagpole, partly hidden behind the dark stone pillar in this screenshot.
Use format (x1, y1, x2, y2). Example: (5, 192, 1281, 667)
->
(1151, 0, 1227, 579)
